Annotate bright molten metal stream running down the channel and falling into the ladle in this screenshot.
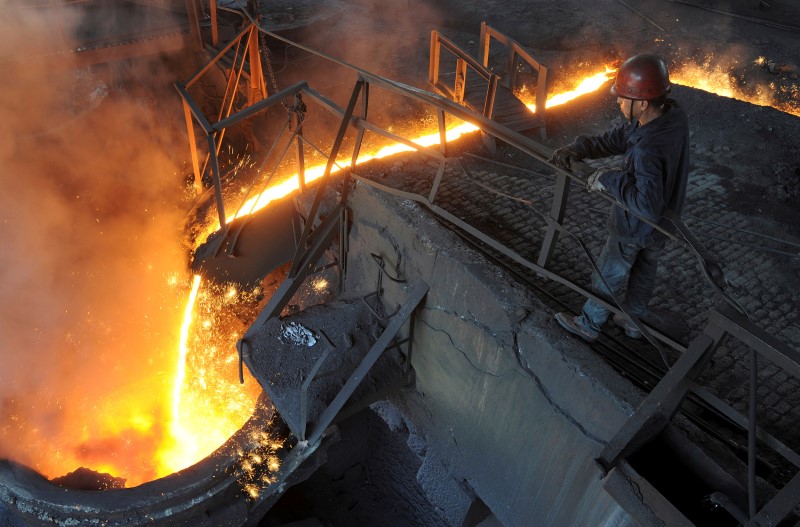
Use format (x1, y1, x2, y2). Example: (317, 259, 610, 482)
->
(26, 67, 788, 486)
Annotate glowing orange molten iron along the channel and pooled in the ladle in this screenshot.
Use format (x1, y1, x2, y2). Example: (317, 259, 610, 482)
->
(12, 63, 788, 486)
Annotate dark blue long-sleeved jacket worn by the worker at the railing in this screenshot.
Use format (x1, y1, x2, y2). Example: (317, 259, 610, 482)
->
(573, 99, 689, 247)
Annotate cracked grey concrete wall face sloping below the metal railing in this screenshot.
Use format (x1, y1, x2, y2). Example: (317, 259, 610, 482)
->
(346, 184, 641, 525)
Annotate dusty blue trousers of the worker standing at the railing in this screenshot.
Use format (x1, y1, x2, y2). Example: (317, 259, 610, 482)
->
(576, 234, 662, 334)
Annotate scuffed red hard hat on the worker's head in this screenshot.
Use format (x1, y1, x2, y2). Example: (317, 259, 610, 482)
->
(611, 54, 671, 101)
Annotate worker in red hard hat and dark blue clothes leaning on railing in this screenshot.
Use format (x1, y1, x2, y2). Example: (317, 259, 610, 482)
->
(549, 54, 689, 342)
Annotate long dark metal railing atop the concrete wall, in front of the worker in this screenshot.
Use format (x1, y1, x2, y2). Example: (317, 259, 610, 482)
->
(178, 16, 800, 525)
